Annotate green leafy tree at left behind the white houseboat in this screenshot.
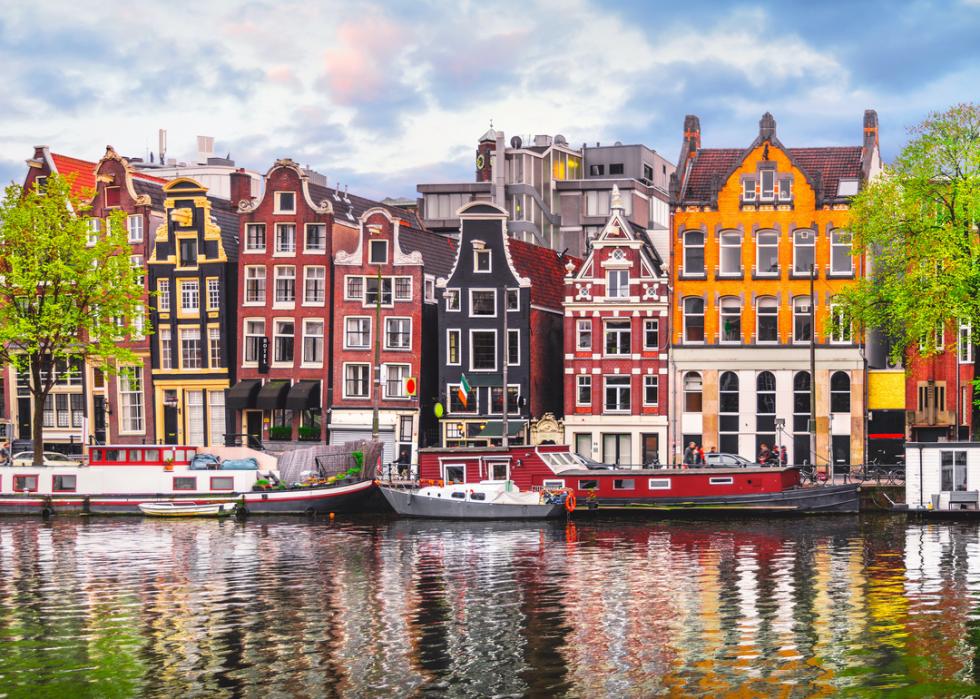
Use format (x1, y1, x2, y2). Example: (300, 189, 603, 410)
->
(0, 175, 145, 464)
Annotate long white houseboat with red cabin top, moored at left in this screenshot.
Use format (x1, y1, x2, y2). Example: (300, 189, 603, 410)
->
(0, 445, 376, 515)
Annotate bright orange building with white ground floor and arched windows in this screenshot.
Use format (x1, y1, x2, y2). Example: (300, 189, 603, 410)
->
(671, 111, 880, 466)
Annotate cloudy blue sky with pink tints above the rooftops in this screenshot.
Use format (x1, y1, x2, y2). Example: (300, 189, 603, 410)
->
(0, 0, 980, 197)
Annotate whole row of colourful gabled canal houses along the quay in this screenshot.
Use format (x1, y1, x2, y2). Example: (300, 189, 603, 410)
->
(4, 111, 960, 465)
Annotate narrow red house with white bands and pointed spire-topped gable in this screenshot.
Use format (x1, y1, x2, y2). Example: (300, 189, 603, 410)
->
(564, 189, 669, 468)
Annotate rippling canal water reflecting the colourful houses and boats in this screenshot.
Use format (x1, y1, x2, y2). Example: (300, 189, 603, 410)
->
(0, 516, 980, 699)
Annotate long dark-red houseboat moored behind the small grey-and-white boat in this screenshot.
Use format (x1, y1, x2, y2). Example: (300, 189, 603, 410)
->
(419, 446, 860, 513)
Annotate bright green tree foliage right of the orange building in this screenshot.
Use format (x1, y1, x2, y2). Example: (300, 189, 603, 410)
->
(837, 104, 980, 424)
